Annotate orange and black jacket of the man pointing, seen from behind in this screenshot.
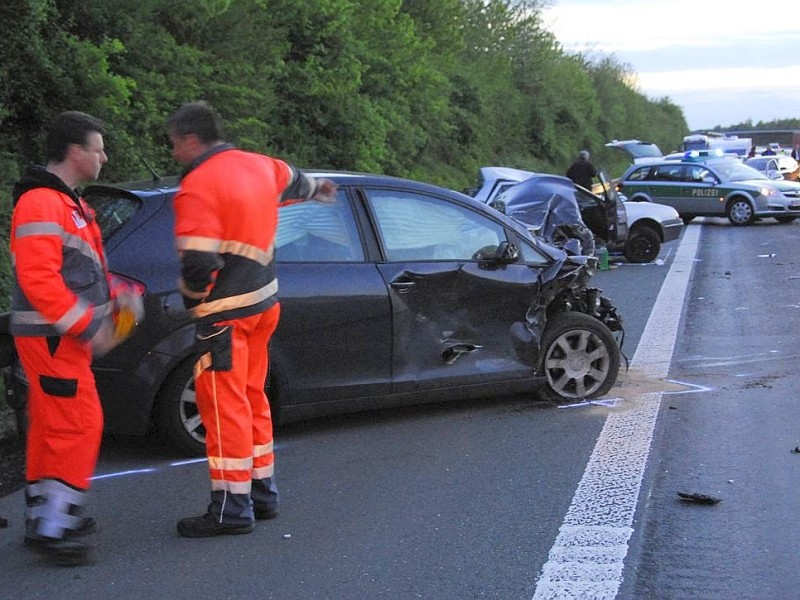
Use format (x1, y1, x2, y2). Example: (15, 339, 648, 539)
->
(174, 144, 296, 322)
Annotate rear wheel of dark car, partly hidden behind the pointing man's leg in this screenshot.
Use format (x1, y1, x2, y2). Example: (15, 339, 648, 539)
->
(157, 357, 206, 456)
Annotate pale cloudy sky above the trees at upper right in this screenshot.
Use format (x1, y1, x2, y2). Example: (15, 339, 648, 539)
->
(543, 0, 800, 129)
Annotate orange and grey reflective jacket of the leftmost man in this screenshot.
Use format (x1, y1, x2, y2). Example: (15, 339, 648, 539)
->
(10, 187, 112, 340)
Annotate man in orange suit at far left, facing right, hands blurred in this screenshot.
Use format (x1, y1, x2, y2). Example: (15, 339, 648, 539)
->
(11, 111, 141, 565)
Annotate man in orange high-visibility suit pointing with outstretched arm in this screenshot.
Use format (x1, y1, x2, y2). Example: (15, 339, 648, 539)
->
(168, 102, 336, 537)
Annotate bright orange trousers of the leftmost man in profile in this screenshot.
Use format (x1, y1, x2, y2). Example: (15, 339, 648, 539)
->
(14, 337, 103, 490)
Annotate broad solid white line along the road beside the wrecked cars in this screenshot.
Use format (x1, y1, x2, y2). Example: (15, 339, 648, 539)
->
(533, 227, 702, 600)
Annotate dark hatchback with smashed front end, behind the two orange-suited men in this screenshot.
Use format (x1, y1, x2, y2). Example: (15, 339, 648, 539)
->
(0, 172, 622, 453)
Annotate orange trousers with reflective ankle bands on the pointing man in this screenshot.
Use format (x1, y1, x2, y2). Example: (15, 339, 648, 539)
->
(195, 304, 280, 494)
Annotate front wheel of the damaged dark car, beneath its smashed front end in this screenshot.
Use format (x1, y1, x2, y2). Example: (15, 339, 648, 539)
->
(539, 312, 620, 401)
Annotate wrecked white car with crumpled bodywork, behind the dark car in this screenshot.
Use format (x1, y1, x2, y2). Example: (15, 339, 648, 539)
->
(471, 167, 683, 263)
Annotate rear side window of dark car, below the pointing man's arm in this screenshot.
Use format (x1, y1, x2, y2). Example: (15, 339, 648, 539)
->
(275, 189, 364, 262)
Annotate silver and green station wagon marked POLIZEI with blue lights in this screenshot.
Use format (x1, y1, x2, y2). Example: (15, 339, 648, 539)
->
(619, 152, 800, 225)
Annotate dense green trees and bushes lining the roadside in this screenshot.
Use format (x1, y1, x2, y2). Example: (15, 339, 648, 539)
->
(0, 0, 796, 316)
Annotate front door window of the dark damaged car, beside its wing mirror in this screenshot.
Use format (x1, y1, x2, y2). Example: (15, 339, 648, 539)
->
(367, 189, 507, 262)
